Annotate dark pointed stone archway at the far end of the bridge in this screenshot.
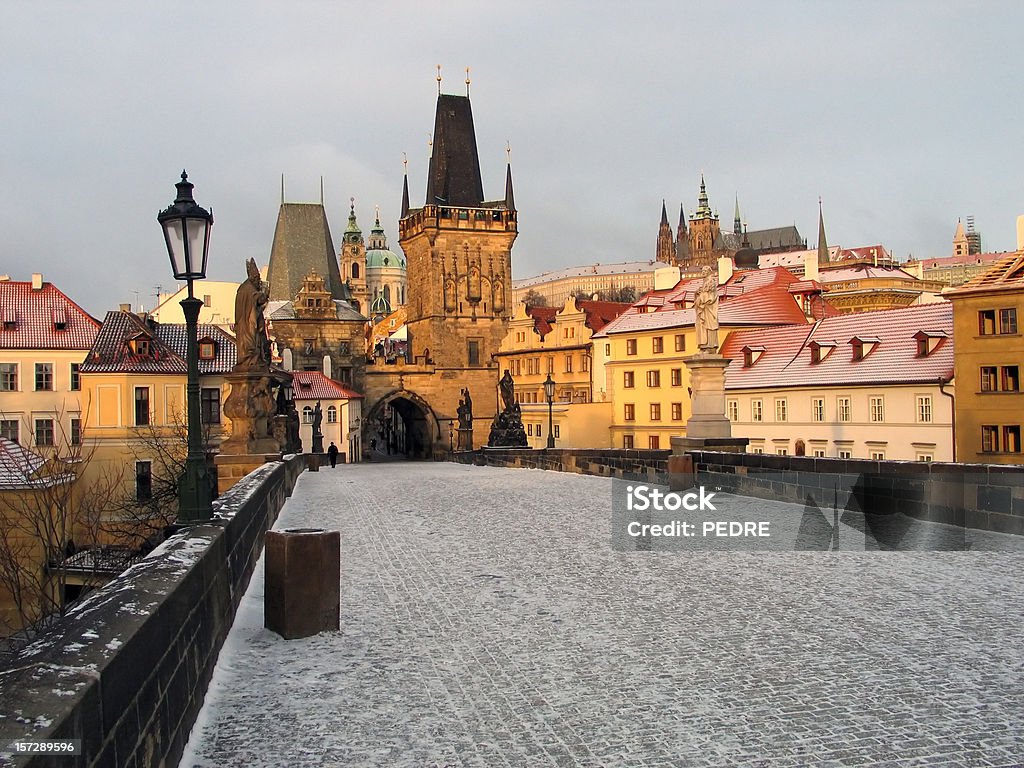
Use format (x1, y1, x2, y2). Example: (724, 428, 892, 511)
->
(362, 390, 440, 461)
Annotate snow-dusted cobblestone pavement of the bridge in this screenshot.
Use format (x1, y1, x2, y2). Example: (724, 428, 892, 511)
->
(182, 463, 1024, 768)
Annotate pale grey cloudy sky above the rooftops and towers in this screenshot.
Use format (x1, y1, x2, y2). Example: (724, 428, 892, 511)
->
(0, 0, 1024, 316)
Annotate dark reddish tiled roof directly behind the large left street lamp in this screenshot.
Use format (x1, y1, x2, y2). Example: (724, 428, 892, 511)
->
(82, 311, 238, 375)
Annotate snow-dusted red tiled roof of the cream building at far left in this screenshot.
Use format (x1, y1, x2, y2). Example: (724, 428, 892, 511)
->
(0, 280, 99, 349)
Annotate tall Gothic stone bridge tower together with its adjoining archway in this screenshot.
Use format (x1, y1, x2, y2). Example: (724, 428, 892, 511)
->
(362, 85, 518, 457)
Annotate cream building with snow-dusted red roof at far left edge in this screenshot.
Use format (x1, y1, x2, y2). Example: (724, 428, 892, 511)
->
(0, 274, 99, 449)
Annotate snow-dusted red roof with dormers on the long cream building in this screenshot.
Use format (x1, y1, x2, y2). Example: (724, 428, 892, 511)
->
(722, 301, 953, 390)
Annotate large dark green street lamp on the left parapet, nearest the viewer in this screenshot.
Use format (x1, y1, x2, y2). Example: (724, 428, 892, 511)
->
(157, 171, 213, 525)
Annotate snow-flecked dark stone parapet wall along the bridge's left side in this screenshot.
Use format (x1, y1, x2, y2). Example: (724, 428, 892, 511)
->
(0, 457, 304, 768)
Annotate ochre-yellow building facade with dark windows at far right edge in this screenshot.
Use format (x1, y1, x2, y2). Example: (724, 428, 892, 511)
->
(946, 256, 1024, 464)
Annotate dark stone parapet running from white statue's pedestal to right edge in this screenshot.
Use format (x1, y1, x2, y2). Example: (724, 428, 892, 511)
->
(672, 451, 1024, 535)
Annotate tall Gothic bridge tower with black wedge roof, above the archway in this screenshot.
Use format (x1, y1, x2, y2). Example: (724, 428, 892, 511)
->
(398, 93, 518, 370)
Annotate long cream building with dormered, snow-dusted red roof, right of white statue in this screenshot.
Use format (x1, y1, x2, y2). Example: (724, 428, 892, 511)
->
(722, 302, 953, 461)
